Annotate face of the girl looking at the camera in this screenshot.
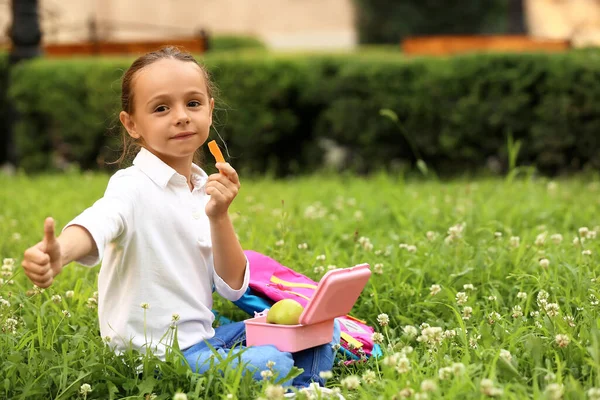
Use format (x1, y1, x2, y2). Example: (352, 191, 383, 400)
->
(120, 59, 214, 169)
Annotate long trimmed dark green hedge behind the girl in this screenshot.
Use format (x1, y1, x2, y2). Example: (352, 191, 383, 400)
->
(10, 51, 600, 175)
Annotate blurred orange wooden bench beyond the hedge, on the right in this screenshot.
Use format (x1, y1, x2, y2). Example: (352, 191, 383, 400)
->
(402, 35, 571, 56)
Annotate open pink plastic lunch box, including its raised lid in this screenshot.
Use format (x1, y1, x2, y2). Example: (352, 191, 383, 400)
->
(244, 264, 371, 353)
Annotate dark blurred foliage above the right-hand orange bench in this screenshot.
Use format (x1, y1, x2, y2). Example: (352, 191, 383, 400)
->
(354, 0, 510, 43)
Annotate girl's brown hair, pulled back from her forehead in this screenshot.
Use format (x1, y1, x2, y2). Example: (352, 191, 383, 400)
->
(111, 46, 216, 165)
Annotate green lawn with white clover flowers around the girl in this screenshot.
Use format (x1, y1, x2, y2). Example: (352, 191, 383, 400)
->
(0, 173, 600, 399)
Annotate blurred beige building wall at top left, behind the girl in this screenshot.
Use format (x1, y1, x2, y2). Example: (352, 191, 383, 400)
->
(0, 0, 356, 49)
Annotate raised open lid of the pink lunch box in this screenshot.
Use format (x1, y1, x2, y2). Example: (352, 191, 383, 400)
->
(299, 264, 371, 325)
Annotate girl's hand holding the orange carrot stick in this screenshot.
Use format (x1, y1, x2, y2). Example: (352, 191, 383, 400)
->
(206, 163, 240, 219)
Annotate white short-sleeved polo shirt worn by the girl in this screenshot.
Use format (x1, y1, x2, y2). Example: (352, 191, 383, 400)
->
(65, 148, 250, 359)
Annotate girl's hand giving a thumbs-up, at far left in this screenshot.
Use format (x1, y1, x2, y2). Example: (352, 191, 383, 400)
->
(21, 217, 63, 288)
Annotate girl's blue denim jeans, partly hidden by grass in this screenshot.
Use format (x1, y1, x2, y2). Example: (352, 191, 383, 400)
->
(183, 321, 340, 387)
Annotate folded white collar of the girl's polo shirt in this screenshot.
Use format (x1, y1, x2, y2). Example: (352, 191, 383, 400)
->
(133, 147, 208, 189)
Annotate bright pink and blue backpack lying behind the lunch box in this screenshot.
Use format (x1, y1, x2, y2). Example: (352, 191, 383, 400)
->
(233, 250, 382, 362)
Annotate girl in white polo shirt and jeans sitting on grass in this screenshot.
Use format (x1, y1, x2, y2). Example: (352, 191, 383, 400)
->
(23, 47, 339, 394)
